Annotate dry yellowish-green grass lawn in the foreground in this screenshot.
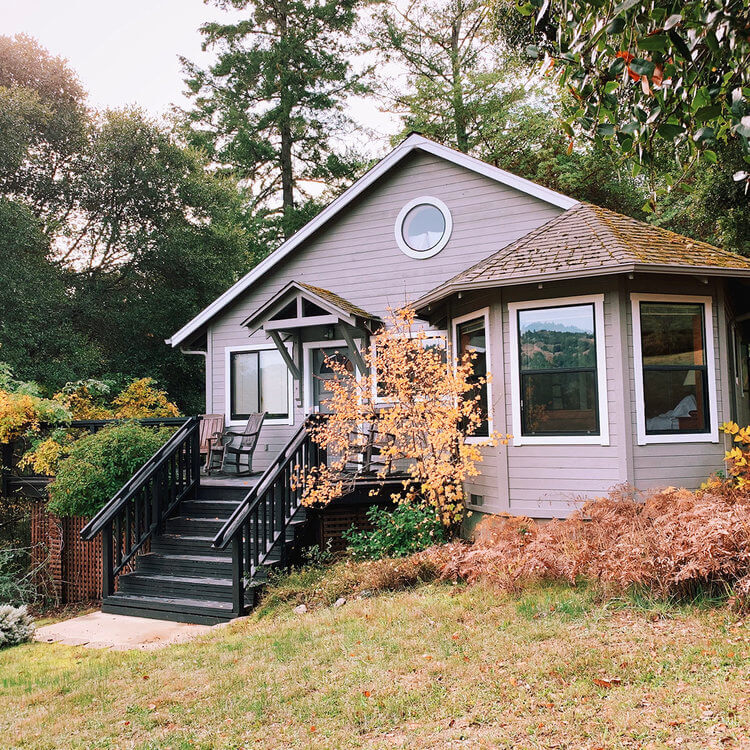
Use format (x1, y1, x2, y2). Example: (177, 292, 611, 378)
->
(0, 584, 750, 749)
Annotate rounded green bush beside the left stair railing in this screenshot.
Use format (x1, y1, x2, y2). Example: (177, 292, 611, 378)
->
(49, 422, 173, 516)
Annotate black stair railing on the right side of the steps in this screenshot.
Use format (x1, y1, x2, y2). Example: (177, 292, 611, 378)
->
(213, 422, 325, 614)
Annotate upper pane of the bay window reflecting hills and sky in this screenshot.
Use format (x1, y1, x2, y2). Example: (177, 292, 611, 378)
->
(518, 305, 596, 370)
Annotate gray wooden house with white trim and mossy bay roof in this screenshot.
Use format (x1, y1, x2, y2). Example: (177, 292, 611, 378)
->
(169, 135, 750, 518)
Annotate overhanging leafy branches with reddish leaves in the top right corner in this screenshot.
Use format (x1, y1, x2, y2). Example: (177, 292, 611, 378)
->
(520, 0, 750, 194)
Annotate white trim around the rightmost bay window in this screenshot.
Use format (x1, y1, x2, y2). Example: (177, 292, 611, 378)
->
(630, 294, 719, 445)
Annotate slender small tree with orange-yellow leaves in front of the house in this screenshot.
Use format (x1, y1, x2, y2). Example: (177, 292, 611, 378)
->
(297, 309, 510, 527)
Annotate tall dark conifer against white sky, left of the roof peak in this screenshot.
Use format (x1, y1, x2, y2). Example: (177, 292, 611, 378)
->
(183, 0, 364, 237)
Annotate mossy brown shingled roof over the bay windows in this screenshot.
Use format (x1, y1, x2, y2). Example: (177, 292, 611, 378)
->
(414, 203, 750, 312)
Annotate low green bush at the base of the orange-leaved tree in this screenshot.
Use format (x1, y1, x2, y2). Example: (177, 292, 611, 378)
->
(344, 503, 446, 560)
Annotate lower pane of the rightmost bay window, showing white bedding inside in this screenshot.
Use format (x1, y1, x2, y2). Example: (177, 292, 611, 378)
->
(643, 368, 708, 434)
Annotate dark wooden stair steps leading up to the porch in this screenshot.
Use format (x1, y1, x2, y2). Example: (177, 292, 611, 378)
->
(102, 486, 305, 625)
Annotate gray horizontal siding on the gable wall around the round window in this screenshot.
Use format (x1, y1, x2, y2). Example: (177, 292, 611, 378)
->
(207, 153, 560, 470)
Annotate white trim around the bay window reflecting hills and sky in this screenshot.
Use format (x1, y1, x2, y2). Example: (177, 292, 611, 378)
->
(508, 294, 609, 446)
